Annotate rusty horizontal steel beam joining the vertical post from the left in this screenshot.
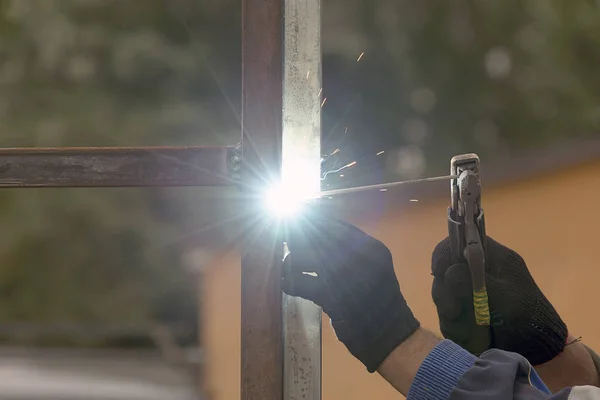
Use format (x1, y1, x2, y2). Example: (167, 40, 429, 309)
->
(0, 147, 239, 188)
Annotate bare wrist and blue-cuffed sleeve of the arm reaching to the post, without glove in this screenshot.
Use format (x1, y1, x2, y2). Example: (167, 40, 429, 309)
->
(378, 329, 600, 400)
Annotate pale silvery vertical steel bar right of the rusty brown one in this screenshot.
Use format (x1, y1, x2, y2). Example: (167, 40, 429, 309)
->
(282, 0, 322, 400)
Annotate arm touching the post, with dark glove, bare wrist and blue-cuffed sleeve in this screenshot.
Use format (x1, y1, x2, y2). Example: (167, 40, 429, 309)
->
(282, 217, 600, 400)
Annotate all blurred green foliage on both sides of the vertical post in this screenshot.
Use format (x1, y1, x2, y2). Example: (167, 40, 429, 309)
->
(0, 0, 600, 340)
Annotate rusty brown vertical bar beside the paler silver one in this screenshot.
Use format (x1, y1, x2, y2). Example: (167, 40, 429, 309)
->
(241, 0, 284, 400)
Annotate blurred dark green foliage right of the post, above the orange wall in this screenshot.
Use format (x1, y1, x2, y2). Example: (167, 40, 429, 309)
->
(324, 0, 600, 184)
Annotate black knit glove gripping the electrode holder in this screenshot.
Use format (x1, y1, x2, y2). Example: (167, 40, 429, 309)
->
(431, 237, 567, 365)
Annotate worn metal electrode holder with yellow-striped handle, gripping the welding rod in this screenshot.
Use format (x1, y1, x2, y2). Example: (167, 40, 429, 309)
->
(448, 154, 490, 332)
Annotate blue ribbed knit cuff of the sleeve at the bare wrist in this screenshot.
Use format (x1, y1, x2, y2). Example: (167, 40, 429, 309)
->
(406, 340, 477, 400)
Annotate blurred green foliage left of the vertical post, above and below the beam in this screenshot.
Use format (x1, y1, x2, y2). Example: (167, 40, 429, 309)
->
(0, 0, 240, 334)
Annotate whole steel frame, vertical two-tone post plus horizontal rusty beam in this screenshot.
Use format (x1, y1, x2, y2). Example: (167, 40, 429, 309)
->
(0, 0, 321, 400)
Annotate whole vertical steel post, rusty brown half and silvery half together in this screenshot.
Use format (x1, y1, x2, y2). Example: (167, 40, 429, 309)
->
(241, 0, 321, 400)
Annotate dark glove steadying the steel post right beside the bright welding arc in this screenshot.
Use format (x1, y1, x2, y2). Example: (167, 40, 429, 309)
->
(283, 215, 419, 372)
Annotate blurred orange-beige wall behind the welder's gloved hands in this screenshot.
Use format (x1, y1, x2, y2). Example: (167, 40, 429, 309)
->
(203, 162, 600, 400)
